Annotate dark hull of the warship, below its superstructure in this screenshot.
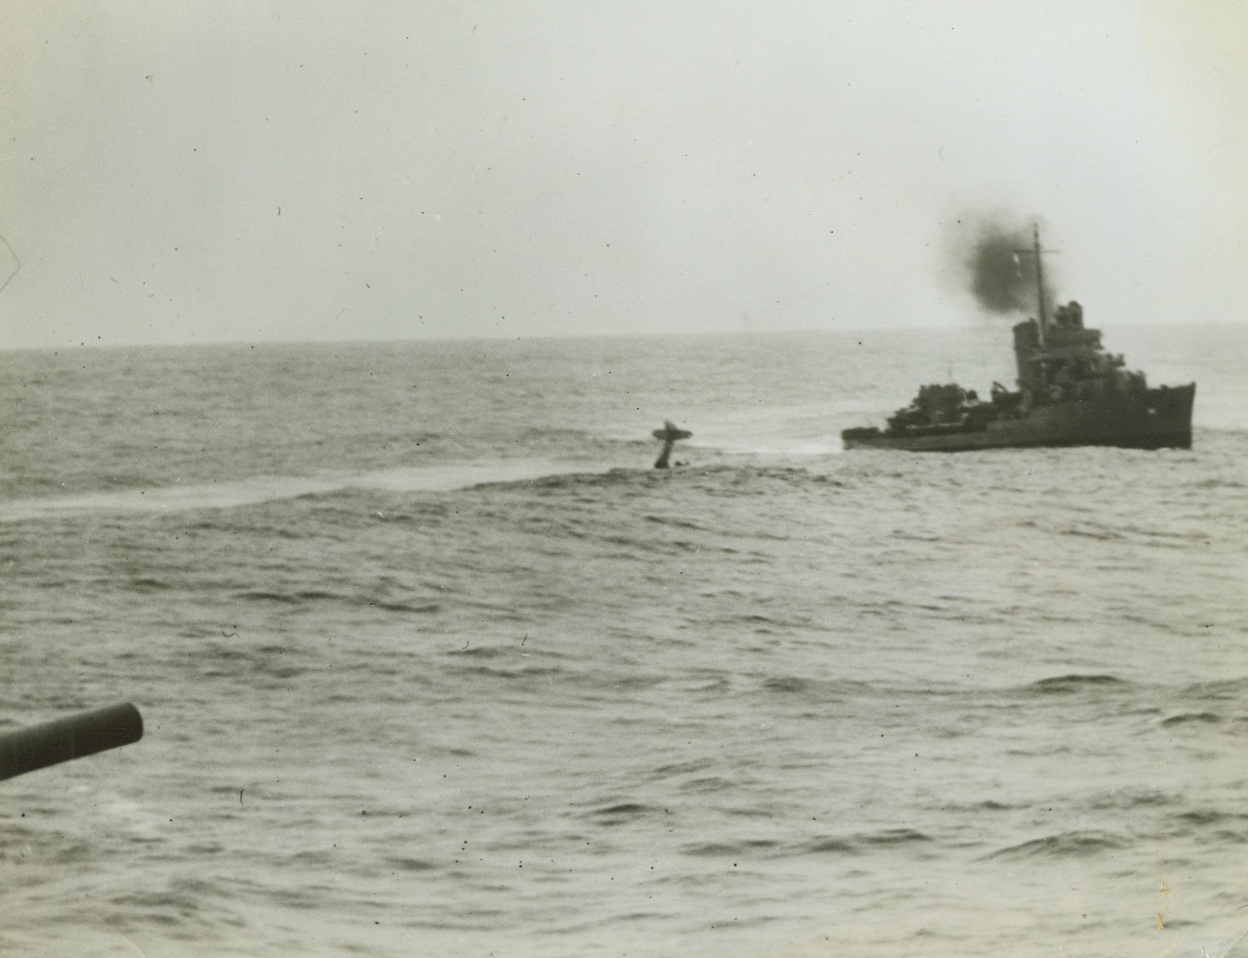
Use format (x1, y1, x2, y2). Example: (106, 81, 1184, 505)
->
(841, 383, 1196, 453)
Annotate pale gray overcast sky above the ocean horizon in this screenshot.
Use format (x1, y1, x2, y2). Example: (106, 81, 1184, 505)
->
(0, 0, 1248, 347)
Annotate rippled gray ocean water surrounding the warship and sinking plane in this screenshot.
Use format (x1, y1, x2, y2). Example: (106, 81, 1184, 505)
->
(0, 326, 1248, 958)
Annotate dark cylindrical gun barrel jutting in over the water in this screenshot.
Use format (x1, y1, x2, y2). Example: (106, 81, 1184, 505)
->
(0, 702, 144, 781)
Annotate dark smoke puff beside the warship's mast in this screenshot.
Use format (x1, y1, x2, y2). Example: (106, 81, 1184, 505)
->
(952, 216, 1053, 314)
